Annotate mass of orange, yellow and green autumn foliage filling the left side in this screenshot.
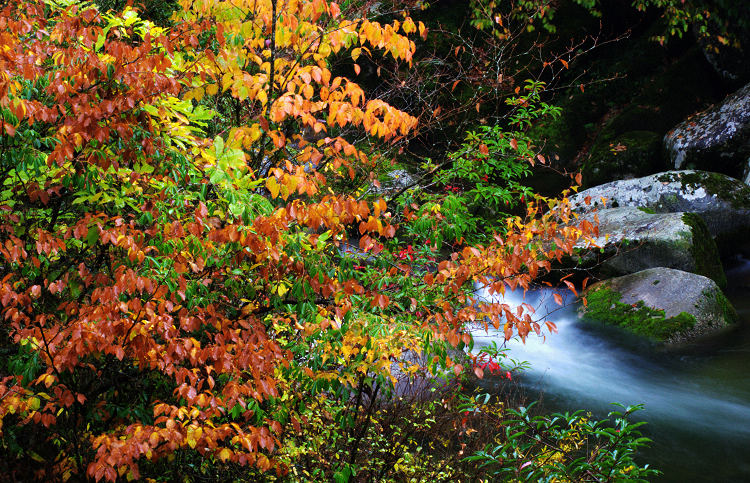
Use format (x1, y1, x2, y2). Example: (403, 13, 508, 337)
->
(0, 0, 592, 481)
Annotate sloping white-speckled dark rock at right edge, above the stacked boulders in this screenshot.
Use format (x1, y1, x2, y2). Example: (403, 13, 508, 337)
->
(664, 84, 750, 178)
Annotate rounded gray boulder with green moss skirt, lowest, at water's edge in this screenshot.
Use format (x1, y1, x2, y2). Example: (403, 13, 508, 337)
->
(580, 268, 737, 344)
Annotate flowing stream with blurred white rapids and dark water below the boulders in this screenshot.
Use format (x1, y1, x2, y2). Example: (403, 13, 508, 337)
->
(474, 259, 750, 482)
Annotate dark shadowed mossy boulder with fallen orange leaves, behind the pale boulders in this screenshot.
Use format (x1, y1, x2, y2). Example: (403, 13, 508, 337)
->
(581, 131, 667, 186)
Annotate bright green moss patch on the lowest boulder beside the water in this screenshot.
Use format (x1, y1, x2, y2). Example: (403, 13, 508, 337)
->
(583, 287, 696, 342)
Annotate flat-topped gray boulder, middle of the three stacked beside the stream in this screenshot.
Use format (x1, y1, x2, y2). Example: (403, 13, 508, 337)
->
(584, 207, 726, 286)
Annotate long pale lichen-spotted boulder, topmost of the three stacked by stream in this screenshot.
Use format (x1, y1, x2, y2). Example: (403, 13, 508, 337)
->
(571, 170, 750, 254)
